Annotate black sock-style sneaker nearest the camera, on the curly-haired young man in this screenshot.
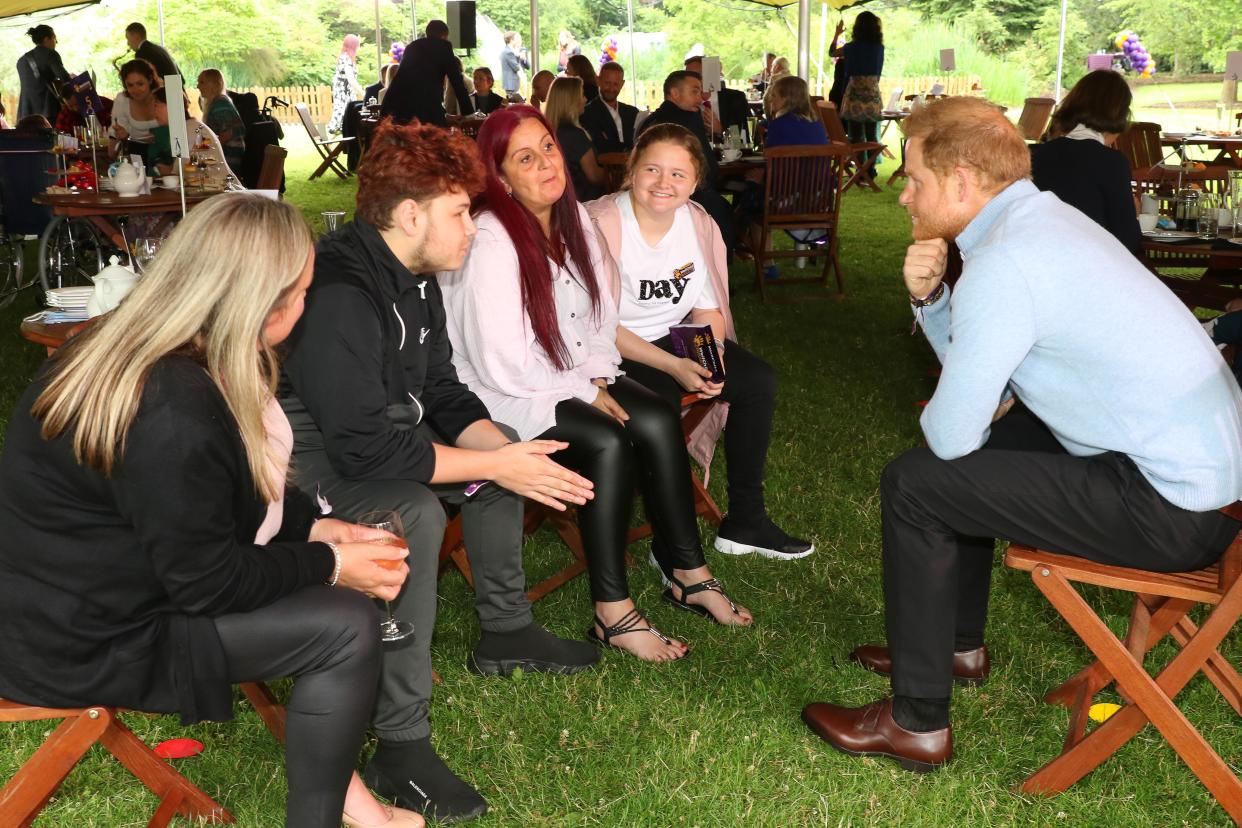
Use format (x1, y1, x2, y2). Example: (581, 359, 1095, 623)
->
(363, 739, 487, 823)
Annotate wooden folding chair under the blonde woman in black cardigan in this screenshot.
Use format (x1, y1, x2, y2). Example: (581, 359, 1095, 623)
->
(0, 682, 284, 828)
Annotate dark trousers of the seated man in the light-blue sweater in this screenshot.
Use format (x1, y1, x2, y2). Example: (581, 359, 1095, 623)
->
(881, 406, 1238, 699)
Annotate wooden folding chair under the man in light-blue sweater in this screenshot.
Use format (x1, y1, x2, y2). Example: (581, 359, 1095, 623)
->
(1005, 503, 1242, 823)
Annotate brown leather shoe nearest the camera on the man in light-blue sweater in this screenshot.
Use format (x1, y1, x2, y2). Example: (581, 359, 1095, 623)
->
(802, 699, 953, 773)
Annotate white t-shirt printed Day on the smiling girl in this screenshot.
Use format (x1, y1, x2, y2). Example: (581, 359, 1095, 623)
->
(614, 191, 720, 343)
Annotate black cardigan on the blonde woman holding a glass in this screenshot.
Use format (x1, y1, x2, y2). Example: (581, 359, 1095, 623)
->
(0, 357, 334, 724)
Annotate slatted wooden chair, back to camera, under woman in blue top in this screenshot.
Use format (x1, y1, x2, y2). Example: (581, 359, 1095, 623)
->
(754, 144, 853, 302)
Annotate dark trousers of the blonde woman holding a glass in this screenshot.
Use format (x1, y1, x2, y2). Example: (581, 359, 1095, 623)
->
(215, 586, 380, 828)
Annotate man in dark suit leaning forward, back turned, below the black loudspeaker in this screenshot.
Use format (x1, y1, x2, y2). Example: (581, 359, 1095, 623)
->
(381, 20, 474, 127)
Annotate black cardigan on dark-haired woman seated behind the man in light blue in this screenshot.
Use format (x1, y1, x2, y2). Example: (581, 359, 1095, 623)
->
(1031, 138, 1143, 254)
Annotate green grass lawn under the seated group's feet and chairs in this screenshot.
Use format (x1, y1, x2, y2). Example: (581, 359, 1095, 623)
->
(0, 144, 1242, 828)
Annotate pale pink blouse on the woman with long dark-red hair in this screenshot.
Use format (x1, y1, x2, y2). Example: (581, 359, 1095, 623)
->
(438, 205, 621, 439)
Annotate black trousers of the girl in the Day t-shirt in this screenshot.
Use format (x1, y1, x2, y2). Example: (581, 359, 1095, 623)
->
(621, 336, 776, 525)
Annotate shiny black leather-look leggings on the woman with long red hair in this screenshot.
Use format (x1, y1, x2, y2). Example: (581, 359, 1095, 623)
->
(539, 376, 707, 601)
